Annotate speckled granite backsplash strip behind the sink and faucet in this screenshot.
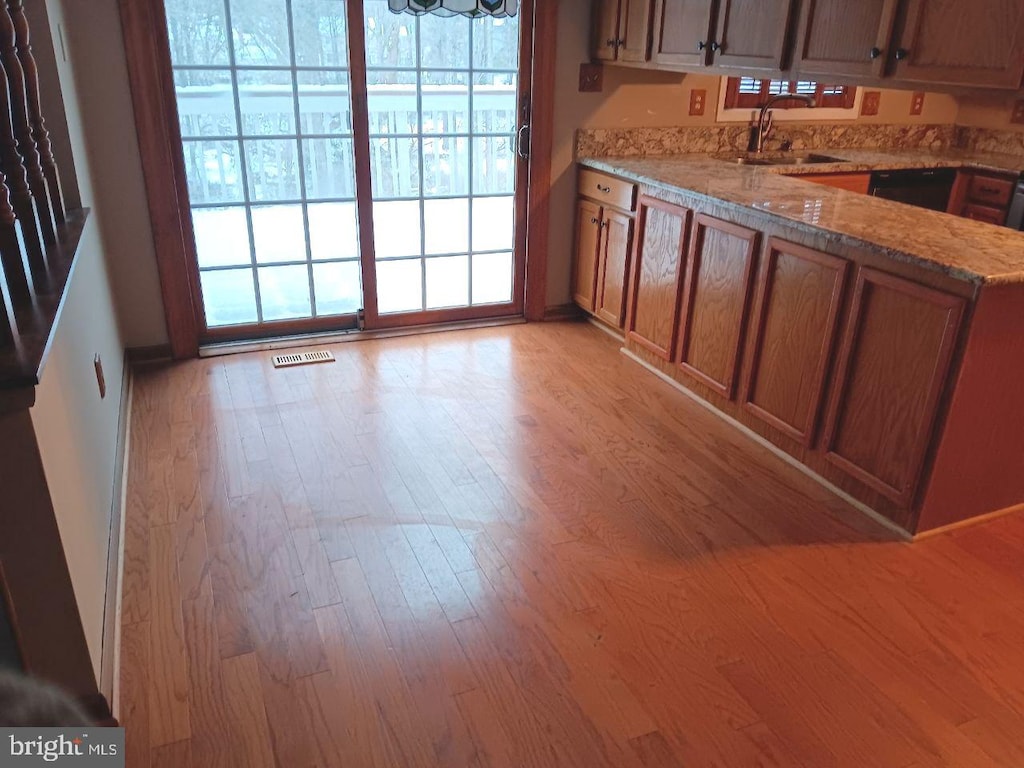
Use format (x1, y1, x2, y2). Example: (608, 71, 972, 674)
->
(575, 123, 957, 158)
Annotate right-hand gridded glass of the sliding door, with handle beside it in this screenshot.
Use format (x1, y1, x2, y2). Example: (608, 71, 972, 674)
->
(364, 0, 519, 325)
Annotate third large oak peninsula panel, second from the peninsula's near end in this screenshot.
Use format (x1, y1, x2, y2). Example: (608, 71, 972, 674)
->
(743, 238, 849, 446)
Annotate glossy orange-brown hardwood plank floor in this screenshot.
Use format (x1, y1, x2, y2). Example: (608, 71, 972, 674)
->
(119, 324, 1024, 768)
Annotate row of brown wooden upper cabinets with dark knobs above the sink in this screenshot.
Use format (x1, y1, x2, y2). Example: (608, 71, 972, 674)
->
(594, 0, 1024, 90)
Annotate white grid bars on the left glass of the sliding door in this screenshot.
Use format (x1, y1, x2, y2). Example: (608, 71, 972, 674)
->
(169, 0, 361, 327)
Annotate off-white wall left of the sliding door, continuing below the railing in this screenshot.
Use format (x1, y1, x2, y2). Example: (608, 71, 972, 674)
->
(18, 0, 143, 680)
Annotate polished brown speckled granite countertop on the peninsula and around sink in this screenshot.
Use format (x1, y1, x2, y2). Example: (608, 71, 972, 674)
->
(579, 148, 1024, 285)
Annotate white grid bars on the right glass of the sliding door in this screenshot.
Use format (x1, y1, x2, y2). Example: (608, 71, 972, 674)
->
(367, 3, 519, 313)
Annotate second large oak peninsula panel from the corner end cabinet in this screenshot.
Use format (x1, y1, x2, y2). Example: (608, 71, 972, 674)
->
(678, 214, 761, 397)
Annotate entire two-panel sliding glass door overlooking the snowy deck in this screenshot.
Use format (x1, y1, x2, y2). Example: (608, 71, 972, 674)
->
(166, 0, 523, 339)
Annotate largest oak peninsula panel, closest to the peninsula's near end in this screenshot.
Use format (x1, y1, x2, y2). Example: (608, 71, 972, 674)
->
(824, 267, 964, 505)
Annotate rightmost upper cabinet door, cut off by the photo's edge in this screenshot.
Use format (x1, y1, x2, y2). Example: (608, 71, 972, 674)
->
(893, 0, 1024, 88)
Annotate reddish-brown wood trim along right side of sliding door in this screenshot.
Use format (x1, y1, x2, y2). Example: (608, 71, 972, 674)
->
(525, 0, 559, 321)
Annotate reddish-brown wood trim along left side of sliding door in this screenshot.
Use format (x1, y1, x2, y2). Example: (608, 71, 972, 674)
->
(118, 0, 200, 358)
